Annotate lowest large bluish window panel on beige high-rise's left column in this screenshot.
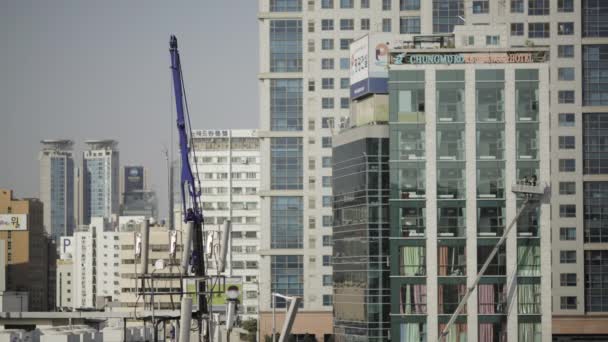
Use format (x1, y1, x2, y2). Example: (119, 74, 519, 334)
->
(270, 255, 304, 308)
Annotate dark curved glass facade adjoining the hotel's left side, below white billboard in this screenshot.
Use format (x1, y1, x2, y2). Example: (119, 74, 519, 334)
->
(333, 134, 390, 342)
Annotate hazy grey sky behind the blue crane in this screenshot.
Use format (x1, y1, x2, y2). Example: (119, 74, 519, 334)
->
(0, 0, 258, 217)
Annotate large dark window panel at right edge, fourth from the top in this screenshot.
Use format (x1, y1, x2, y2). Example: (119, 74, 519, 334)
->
(583, 181, 608, 243)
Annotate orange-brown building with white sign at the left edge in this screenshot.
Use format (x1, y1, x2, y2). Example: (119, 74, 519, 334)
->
(0, 189, 50, 311)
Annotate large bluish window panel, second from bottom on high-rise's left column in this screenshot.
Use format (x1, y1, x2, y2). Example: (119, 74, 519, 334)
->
(270, 196, 304, 248)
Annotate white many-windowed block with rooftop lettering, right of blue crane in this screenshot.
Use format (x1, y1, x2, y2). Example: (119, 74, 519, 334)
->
(190, 129, 260, 319)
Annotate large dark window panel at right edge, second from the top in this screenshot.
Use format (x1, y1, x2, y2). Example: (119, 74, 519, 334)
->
(583, 45, 608, 106)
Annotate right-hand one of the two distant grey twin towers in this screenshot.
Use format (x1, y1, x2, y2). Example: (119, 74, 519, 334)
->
(81, 140, 120, 224)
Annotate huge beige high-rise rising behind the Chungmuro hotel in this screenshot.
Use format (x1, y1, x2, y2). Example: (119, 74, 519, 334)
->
(258, 0, 608, 339)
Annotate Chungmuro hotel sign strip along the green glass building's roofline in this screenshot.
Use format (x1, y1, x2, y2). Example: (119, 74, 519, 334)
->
(391, 52, 545, 65)
